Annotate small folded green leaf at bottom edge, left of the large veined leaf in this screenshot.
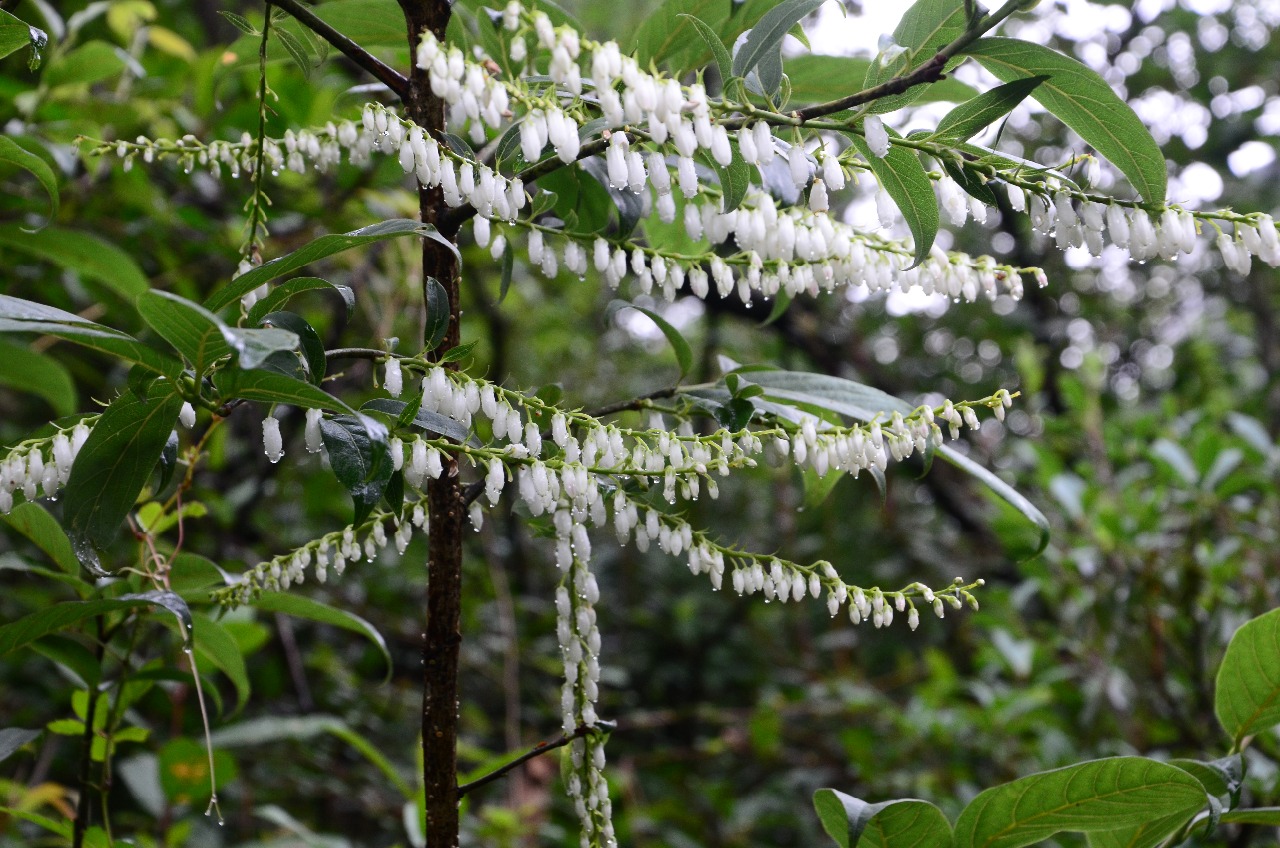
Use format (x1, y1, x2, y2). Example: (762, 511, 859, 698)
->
(813, 789, 951, 848)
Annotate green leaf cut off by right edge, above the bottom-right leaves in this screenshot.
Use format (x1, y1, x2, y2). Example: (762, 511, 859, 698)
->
(1213, 610, 1280, 749)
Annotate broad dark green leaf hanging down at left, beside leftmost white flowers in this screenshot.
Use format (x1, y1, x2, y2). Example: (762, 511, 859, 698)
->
(63, 382, 182, 570)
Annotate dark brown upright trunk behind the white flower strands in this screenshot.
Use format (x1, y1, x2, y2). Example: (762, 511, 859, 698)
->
(399, 0, 465, 848)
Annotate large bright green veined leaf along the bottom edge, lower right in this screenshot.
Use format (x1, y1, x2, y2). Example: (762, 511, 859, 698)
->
(955, 757, 1207, 848)
